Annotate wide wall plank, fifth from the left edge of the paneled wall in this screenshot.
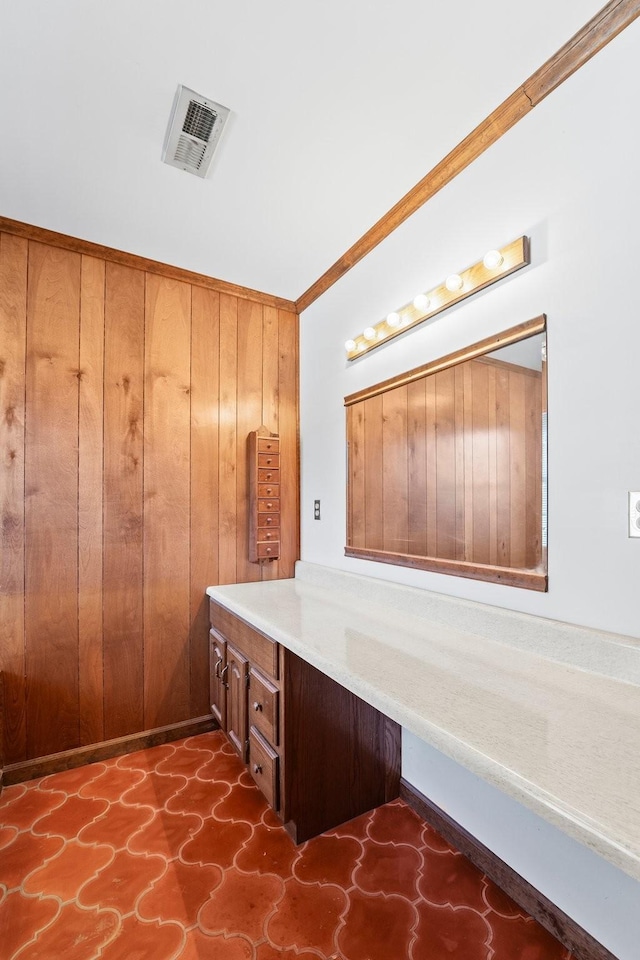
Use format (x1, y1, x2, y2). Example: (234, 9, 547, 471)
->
(144, 274, 191, 729)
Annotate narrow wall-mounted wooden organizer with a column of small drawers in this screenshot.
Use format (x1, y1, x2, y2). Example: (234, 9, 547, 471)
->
(247, 427, 280, 563)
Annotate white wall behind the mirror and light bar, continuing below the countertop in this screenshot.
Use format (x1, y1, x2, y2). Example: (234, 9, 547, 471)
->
(301, 21, 640, 960)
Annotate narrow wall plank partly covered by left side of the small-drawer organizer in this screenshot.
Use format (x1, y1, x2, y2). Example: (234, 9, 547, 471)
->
(235, 300, 262, 582)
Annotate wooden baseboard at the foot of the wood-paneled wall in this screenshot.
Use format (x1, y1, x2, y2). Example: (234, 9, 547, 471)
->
(2, 716, 218, 787)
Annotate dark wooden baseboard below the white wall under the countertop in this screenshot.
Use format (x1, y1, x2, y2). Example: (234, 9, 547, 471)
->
(400, 779, 616, 960)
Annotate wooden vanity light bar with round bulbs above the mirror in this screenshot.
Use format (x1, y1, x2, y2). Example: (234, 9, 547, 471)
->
(344, 237, 531, 360)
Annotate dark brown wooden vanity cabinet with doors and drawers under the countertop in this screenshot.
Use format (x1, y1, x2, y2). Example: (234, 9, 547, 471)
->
(210, 600, 400, 843)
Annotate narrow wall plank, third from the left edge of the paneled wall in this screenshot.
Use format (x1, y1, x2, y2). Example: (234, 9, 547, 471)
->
(78, 256, 105, 744)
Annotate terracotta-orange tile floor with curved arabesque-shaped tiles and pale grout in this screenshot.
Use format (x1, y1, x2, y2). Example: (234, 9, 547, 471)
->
(0, 732, 571, 960)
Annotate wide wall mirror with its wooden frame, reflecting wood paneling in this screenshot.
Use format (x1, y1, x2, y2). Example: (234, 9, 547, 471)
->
(345, 316, 547, 590)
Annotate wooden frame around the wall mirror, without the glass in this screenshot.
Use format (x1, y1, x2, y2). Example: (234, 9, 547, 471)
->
(344, 314, 548, 591)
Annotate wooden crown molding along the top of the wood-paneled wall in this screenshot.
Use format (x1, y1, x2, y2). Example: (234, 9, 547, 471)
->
(0, 217, 297, 313)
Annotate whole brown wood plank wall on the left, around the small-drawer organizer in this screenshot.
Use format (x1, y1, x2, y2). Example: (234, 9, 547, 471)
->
(0, 232, 299, 763)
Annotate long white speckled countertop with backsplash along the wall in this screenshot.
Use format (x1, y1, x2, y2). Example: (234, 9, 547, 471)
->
(207, 563, 640, 880)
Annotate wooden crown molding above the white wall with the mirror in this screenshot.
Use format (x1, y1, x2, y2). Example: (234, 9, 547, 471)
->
(296, 0, 640, 313)
